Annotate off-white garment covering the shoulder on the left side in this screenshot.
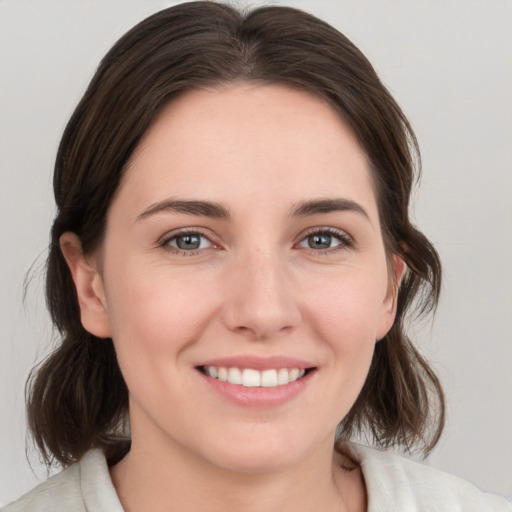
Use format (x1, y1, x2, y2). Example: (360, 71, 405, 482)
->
(2, 450, 123, 512)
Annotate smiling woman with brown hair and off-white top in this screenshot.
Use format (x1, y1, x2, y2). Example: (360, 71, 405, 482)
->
(6, 2, 510, 511)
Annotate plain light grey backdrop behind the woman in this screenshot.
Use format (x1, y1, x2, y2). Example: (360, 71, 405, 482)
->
(0, 0, 512, 504)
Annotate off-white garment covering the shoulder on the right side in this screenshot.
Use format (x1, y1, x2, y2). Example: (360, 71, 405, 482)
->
(347, 444, 512, 512)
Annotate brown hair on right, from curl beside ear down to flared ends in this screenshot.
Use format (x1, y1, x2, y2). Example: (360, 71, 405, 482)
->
(338, 224, 446, 456)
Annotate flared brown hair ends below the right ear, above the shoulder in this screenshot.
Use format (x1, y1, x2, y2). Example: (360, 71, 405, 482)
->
(338, 325, 445, 456)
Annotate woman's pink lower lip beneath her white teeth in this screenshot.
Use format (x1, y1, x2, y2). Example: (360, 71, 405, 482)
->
(197, 370, 315, 408)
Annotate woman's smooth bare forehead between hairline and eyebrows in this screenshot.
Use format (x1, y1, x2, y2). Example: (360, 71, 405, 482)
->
(117, 83, 375, 220)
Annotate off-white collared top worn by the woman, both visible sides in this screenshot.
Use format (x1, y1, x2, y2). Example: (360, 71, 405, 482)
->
(2, 444, 512, 512)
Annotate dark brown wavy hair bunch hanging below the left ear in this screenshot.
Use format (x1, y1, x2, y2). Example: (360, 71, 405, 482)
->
(26, 330, 128, 466)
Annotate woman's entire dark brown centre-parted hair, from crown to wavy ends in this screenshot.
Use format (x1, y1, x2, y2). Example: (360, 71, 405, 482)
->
(27, 2, 444, 466)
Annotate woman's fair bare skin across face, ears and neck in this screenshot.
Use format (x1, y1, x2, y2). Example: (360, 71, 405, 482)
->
(61, 84, 403, 512)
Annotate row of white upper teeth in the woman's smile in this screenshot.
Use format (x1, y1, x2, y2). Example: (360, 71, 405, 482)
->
(204, 366, 306, 388)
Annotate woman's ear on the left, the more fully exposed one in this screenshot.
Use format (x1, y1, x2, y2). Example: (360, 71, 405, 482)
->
(60, 232, 111, 338)
